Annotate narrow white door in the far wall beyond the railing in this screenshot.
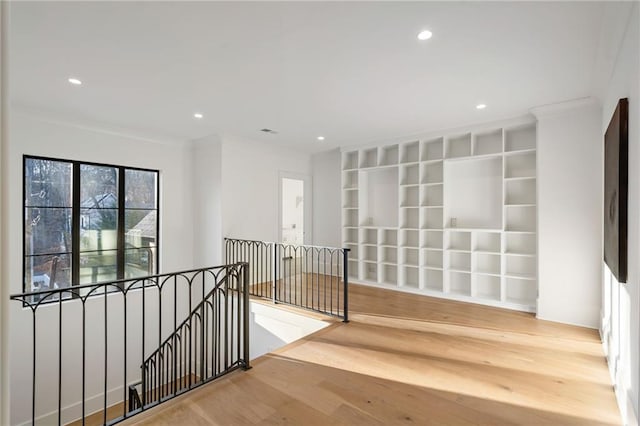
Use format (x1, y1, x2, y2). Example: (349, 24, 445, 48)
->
(278, 172, 311, 244)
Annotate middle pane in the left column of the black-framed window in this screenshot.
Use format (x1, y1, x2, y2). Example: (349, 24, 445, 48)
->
(24, 207, 71, 255)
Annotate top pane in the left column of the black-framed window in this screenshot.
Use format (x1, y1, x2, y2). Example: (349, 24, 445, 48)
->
(24, 158, 73, 207)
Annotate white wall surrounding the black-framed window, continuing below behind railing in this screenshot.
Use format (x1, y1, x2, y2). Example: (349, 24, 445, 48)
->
(4, 112, 194, 424)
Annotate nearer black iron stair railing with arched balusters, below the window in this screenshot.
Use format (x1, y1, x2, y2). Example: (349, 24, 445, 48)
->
(11, 263, 249, 424)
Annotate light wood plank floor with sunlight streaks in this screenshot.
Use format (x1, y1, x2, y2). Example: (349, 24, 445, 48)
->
(124, 285, 621, 426)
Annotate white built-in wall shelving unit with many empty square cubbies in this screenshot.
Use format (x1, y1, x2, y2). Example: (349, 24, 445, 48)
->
(342, 120, 538, 311)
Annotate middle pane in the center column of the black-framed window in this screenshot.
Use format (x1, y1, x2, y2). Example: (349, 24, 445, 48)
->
(80, 209, 118, 251)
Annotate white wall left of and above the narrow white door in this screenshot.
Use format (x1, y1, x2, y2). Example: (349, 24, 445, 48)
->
(222, 136, 311, 241)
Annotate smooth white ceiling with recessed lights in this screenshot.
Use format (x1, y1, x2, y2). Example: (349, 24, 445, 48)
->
(9, 2, 603, 151)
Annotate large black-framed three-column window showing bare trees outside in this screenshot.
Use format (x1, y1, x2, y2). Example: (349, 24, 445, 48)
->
(23, 156, 159, 292)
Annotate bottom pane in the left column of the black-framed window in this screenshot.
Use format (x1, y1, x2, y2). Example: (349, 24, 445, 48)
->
(25, 254, 71, 292)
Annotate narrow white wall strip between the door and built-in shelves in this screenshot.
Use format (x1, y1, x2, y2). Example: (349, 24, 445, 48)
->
(311, 149, 342, 247)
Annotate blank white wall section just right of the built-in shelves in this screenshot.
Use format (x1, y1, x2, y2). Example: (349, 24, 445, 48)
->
(534, 100, 603, 328)
